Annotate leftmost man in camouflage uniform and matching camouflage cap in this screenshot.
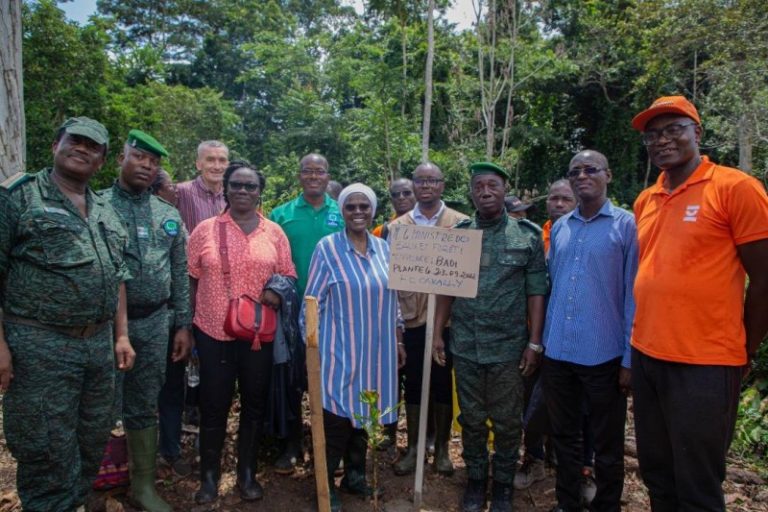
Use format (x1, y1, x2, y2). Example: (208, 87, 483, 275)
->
(0, 117, 134, 512)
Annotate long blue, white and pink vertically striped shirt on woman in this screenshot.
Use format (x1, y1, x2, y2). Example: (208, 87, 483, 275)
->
(307, 231, 399, 428)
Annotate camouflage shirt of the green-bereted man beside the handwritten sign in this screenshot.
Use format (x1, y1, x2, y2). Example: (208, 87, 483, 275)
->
(450, 212, 549, 364)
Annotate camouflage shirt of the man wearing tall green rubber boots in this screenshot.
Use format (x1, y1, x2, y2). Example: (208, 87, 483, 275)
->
(102, 182, 192, 327)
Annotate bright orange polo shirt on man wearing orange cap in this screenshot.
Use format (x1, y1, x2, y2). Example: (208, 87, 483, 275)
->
(632, 157, 768, 366)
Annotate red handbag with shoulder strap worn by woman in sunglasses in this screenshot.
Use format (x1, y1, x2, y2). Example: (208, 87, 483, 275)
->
(219, 223, 277, 350)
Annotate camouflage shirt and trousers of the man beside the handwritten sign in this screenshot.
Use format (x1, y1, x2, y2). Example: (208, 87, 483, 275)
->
(449, 213, 548, 484)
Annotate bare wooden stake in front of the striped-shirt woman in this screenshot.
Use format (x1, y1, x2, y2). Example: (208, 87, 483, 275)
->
(304, 296, 331, 512)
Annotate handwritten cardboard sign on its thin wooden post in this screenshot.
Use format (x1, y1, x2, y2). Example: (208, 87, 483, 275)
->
(388, 224, 483, 508)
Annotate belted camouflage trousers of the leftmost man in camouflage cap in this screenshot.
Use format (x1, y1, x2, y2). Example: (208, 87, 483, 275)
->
(3, 322, 114, 512)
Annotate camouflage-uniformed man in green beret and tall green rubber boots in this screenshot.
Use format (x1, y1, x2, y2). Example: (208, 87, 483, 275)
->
(104, 130, 191, 512)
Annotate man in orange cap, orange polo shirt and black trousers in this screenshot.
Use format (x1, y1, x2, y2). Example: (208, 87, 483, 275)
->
(632, 96, 768, 511)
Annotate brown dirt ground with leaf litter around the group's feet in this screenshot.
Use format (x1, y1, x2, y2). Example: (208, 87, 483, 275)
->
(0, 400, 768, 512)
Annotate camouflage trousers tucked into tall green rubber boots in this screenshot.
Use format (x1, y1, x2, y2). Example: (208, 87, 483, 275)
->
(115, 308, 169, 430)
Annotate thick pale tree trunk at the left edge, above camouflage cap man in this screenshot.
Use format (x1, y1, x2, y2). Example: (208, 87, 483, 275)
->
(0, 0, 26, 178)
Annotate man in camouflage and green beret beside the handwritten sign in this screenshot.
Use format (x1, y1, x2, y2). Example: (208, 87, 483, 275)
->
(433, 162, 547, 512)
